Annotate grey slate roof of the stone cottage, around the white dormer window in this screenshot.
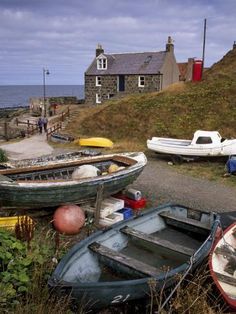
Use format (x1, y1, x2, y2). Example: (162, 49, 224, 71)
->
(85, 51, 167, 75)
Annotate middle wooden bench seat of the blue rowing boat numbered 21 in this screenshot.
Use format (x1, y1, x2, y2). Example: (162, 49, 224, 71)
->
(120, 227, 195, 256)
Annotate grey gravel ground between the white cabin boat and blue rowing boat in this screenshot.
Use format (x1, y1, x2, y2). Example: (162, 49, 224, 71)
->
(132, 156, 236, 227)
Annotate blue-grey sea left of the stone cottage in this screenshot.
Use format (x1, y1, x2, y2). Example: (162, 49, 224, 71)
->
(0, 85, 84, 109)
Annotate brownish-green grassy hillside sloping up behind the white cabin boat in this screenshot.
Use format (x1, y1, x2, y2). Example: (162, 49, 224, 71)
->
(66, 49, 236, 144)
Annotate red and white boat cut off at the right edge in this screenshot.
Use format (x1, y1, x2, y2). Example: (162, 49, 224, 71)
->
(209, 222, 236, 312)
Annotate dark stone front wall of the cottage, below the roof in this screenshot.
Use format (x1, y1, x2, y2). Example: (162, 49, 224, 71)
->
(85, 75, 161, 104)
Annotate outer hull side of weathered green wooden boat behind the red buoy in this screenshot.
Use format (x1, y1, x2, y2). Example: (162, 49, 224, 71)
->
(0, 153, 147, 209)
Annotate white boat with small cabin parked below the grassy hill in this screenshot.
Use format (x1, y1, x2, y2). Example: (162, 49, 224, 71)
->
(147, 130, 236, 157)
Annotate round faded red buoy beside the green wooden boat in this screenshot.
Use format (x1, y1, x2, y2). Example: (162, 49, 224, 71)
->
(53, 204, 85, 235)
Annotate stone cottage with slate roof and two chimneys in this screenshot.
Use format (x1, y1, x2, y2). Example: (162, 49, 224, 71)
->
(85, 37, 180, 104)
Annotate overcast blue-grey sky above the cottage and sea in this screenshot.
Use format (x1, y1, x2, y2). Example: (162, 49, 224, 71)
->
(0, 0, 236, 85)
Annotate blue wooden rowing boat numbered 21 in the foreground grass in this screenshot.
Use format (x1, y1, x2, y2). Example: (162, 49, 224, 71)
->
(49, 204, 219, 308)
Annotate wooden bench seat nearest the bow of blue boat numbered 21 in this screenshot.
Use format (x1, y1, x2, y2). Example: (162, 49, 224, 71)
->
(89, 242, 162, 277)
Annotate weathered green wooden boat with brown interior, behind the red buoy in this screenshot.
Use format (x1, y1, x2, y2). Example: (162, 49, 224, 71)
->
(0, 152, 147, 209)
